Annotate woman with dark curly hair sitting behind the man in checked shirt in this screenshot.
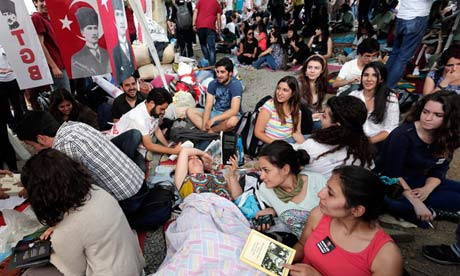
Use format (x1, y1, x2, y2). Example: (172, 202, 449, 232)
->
(48, 89, 99, 129)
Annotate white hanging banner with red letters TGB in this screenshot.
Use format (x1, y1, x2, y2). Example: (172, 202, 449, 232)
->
(0, 0, 53, 89)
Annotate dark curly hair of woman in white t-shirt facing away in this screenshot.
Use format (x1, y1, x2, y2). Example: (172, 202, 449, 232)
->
(311, 96, 375, 167)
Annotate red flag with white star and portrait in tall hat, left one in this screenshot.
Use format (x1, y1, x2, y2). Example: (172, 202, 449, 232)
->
(46, 0, 112, 79)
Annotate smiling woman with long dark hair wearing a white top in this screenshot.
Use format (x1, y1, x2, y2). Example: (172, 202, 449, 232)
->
(349, 61, 399, 146)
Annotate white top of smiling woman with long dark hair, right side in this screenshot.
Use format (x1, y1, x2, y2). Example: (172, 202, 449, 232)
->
(349, 90, 399, 137)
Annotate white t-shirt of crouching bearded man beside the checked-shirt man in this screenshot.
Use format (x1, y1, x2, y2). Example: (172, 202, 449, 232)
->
(110, 101, 160, 156)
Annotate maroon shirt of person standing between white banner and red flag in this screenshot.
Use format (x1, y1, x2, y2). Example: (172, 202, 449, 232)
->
(32, 12, 64, 69)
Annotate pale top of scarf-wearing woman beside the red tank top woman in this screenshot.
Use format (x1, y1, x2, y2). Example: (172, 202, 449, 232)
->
(258, 172, 327, 238)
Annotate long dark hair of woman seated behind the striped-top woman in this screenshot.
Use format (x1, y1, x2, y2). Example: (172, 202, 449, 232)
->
(299, 55, 327, 110)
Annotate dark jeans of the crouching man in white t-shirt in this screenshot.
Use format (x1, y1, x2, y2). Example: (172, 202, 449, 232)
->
(111, 129, 146, 172)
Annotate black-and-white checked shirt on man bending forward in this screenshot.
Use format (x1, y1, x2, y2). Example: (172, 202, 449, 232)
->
(53, 122, 144, 201)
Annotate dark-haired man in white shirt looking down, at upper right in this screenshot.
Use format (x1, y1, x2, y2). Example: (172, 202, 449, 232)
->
(332, 38, 380, 96)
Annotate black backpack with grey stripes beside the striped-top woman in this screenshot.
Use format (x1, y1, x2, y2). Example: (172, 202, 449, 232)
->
(235, 96, 272, 158)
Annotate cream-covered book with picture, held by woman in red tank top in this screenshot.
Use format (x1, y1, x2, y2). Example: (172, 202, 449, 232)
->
(240, 230, 295, 276)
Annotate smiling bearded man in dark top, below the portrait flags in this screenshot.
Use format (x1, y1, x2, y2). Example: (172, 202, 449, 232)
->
(112, 76, 145, 123)
